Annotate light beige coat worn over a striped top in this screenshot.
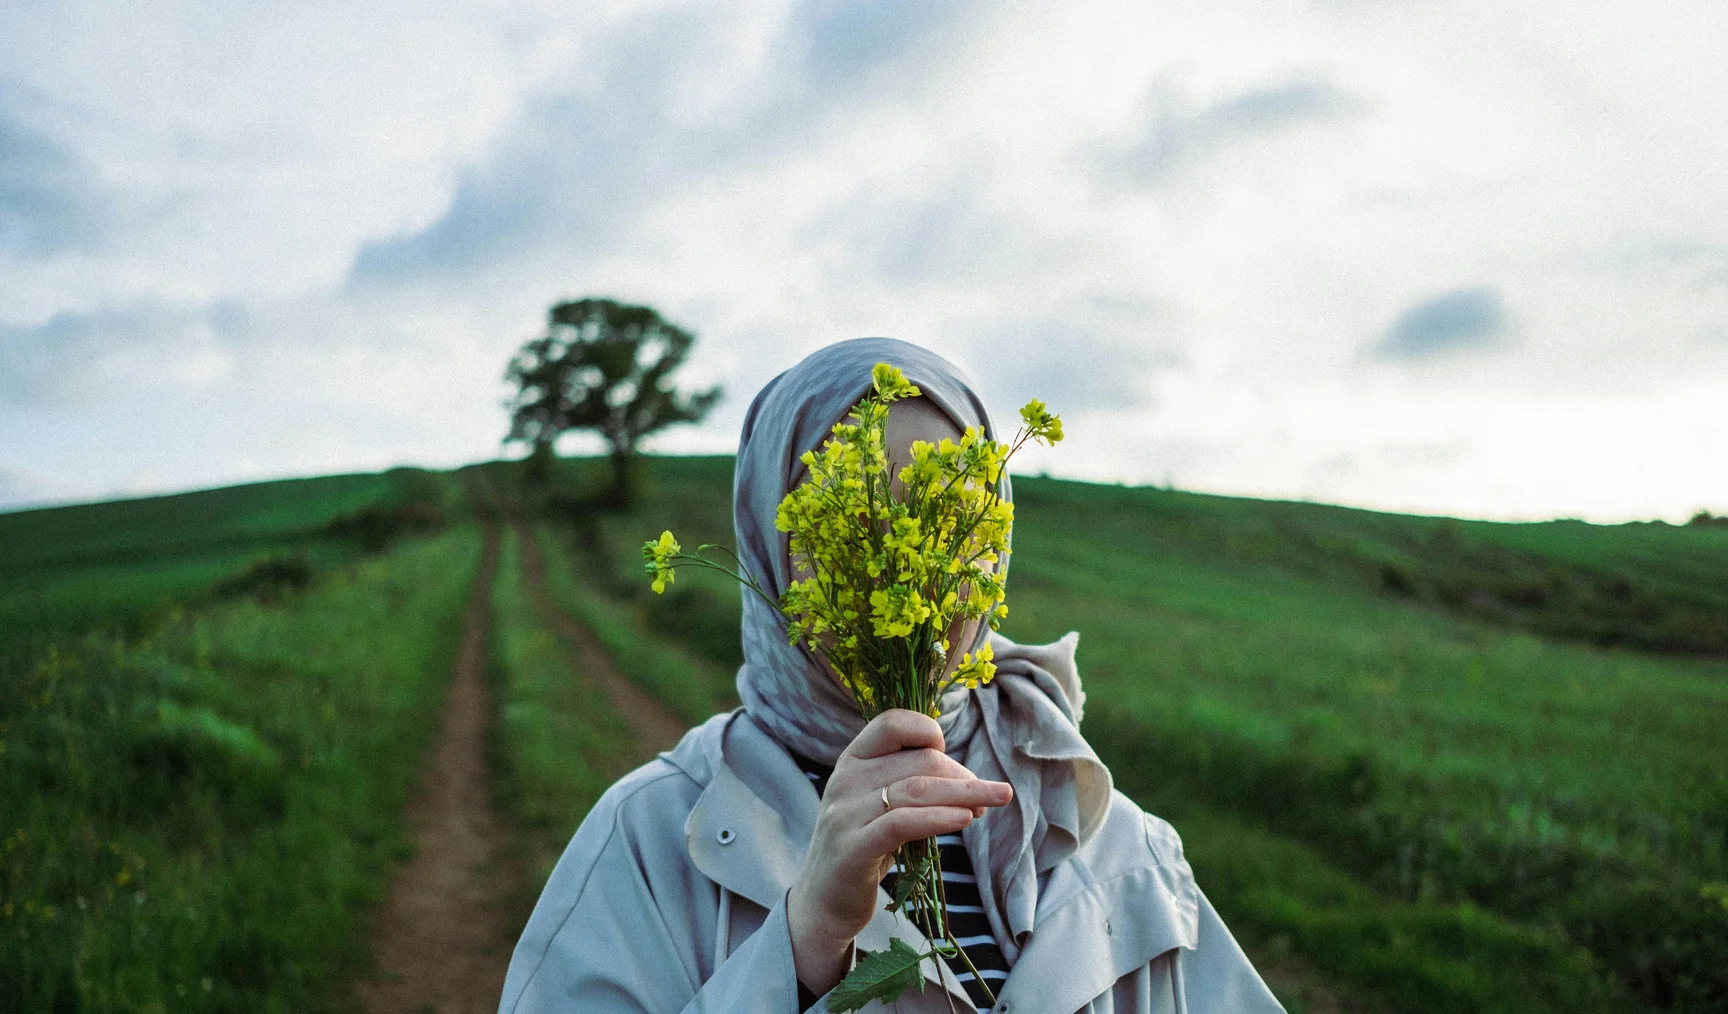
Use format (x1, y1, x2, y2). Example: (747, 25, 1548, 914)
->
(498, 712, 1282, 1014)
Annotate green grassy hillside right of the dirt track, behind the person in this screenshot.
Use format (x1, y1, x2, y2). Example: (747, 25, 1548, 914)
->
(539, 458, 1728, 1011)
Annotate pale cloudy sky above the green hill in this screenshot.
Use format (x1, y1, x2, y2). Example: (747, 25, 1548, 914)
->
(0, 0, 1728, 520)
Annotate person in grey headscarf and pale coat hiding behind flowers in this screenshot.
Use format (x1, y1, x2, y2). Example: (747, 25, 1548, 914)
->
(499, 339, 1282, 1014)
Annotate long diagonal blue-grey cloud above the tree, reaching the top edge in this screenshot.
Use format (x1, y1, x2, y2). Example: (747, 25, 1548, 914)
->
(351, 0, 988, 285)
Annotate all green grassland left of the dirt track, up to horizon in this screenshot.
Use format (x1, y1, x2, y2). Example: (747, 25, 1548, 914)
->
(0, 472, 479, 1012)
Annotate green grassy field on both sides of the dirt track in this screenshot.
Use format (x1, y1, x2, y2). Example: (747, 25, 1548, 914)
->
(0, 458, 1728, 1014)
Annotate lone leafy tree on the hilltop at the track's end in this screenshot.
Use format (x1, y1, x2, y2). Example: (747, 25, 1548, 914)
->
(505, 299, 721, 506)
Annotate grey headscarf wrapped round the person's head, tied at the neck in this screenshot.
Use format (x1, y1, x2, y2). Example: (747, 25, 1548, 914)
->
(733, 339, 1111, 964)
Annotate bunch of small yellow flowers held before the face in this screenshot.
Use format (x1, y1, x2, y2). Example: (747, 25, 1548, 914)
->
(643, 363, 1063, 1011)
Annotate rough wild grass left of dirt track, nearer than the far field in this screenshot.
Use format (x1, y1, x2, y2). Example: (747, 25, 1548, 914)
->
(0, 529, 479, 1012)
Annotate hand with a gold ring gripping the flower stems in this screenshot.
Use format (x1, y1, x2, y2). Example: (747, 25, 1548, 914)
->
(786, 708, 1014, 995)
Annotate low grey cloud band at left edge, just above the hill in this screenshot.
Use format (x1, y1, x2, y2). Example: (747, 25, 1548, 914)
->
(0, 302, 242, 406)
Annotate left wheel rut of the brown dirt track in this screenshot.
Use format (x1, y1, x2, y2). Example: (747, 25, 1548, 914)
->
(359, 523, 520, 1014)
